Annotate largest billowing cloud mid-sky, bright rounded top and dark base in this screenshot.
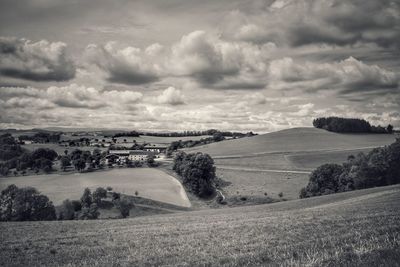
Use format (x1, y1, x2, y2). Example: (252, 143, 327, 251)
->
(168, 31, 275, 89)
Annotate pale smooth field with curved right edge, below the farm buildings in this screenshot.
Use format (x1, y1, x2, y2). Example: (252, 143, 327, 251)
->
(0, 168, 190, 207)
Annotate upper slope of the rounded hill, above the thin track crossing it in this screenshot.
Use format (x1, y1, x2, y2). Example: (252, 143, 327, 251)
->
(186, 128, 395, 156)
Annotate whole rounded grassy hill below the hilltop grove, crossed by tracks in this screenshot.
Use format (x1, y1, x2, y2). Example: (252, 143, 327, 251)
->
(186, 128, 396, 199)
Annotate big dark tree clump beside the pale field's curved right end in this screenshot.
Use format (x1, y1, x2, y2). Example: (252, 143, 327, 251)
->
(173, 152, 216, 197)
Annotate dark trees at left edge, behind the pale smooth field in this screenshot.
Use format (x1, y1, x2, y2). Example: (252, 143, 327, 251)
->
(0, 134, 58, 176)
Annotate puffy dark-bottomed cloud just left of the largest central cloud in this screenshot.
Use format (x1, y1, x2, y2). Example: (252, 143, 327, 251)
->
(85, 42, 161, 85)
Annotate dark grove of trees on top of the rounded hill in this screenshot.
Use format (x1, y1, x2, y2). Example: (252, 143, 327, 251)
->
(313, 117, 393, 133)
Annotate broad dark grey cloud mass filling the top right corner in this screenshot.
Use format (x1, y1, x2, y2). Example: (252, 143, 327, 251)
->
(224, 0, 400, 49)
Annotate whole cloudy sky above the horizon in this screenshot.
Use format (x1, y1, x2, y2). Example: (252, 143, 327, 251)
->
(0, 0, 400, 133)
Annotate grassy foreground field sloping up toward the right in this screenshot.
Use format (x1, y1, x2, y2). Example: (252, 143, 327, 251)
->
(0, 185, 400, 266)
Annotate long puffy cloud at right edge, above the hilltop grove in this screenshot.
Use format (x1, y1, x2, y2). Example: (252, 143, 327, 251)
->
(269, 57, 400, 94)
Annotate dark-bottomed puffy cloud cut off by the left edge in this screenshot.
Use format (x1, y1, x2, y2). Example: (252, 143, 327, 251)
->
(0, 37, 75, 81)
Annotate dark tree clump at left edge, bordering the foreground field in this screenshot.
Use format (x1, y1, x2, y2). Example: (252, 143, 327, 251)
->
(0, 185, 56, 221)
